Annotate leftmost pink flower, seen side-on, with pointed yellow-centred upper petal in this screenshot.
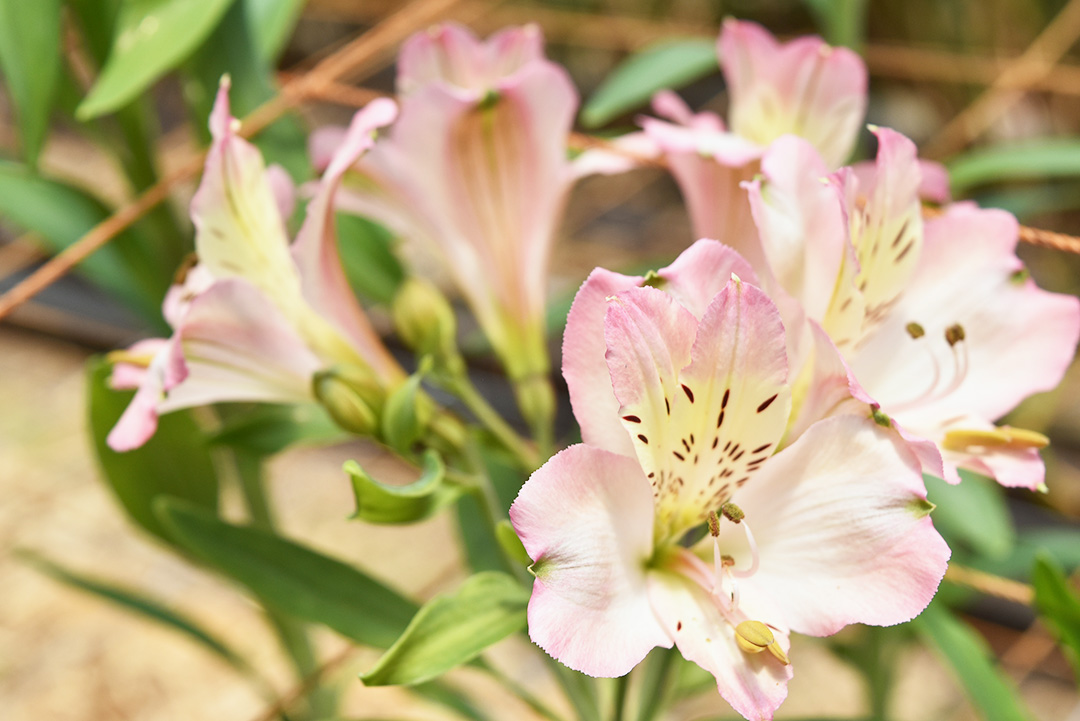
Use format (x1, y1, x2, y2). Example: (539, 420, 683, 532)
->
(108, 82, 404, 451)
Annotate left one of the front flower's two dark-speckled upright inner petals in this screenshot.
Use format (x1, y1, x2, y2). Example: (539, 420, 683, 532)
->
(604, 286, 698, 496)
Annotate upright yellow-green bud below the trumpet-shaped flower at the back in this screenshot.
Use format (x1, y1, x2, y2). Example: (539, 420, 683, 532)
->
(392, 277, 458, 361)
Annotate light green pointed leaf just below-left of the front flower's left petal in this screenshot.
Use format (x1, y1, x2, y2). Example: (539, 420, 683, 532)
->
(360, 572, 529, 686)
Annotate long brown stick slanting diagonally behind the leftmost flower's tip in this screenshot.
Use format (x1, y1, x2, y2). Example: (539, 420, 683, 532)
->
(0, 0, 460, 321)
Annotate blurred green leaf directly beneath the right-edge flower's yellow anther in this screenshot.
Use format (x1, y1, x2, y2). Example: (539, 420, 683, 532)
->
(923, 470, 1016, 558)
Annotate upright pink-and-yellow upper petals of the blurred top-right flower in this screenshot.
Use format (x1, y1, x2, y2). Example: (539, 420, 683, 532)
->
(717, 19, 866, 167)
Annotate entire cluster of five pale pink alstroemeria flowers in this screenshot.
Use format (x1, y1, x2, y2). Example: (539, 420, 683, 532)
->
(109, 21, 1080, 719)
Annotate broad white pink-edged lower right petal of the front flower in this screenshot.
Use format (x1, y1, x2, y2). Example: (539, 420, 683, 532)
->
(720, 416, 949, 636)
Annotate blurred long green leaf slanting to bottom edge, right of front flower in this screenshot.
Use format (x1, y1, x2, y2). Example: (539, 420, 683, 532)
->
(914, 601, 1031, 721)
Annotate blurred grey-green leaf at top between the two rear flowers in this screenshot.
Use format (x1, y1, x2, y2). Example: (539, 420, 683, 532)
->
(581, 38, 718, 127)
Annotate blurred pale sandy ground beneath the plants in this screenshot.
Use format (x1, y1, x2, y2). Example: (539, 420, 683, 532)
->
(0, 328, 1077, 721)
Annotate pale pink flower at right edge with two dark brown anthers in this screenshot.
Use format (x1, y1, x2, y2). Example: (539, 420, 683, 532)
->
(750, 128, 1080, 489)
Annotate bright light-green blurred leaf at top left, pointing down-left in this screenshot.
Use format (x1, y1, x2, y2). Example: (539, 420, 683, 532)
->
(77, 0, 235, 120)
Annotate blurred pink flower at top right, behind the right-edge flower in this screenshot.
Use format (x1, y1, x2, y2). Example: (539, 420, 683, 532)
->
(642, 19, 866, 255)
